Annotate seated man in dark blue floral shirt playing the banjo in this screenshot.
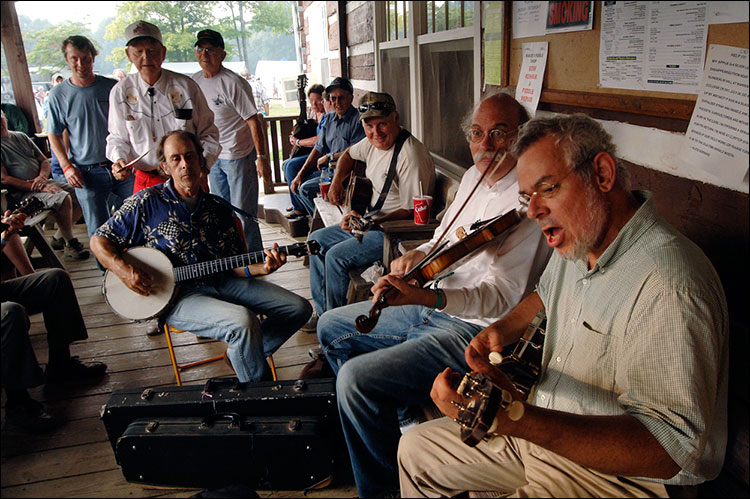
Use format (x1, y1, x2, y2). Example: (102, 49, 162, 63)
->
(90, 130, 312, 382)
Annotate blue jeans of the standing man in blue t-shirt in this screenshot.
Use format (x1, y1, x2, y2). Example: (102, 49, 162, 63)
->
(75, 165, 135, 238)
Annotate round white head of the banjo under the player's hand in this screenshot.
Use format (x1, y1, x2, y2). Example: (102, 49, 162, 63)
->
(102, 247, 176, 321)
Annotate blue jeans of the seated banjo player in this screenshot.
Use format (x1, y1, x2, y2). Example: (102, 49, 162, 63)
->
(166, 275, 312, 382)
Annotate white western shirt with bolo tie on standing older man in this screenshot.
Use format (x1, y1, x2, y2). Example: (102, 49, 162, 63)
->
(107, 69, 221, 171)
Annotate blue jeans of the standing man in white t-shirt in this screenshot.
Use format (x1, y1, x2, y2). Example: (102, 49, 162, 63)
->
(208, 150, 263, 251)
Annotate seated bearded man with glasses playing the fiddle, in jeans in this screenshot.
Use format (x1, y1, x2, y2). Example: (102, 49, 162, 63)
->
(311, 93, 550, 497)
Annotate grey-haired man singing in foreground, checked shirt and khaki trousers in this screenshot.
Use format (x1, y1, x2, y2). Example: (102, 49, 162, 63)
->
(399, 115, 729, 497)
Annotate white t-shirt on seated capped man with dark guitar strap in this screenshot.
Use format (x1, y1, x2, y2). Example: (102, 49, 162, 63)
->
(349, 132, 435, 217)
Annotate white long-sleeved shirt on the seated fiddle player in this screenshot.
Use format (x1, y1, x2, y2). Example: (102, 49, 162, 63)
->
(417, 166, 551, 327)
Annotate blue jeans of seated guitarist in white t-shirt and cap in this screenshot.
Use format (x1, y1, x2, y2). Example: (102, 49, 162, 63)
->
(308, 225, 383, 315)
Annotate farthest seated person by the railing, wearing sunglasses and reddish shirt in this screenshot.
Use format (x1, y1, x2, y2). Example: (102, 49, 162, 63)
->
(284, 83, 332, 218)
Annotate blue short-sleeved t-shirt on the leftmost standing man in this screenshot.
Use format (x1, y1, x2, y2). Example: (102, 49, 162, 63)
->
(44, 75, 117, 165)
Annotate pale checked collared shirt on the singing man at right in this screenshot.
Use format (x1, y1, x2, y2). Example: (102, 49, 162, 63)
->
(533, 191, 729, 485)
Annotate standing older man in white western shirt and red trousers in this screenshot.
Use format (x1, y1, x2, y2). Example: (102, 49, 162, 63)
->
(107, 21, 221, 192)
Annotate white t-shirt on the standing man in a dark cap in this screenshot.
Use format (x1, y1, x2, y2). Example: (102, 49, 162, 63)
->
(193, 67, 258, 159)
